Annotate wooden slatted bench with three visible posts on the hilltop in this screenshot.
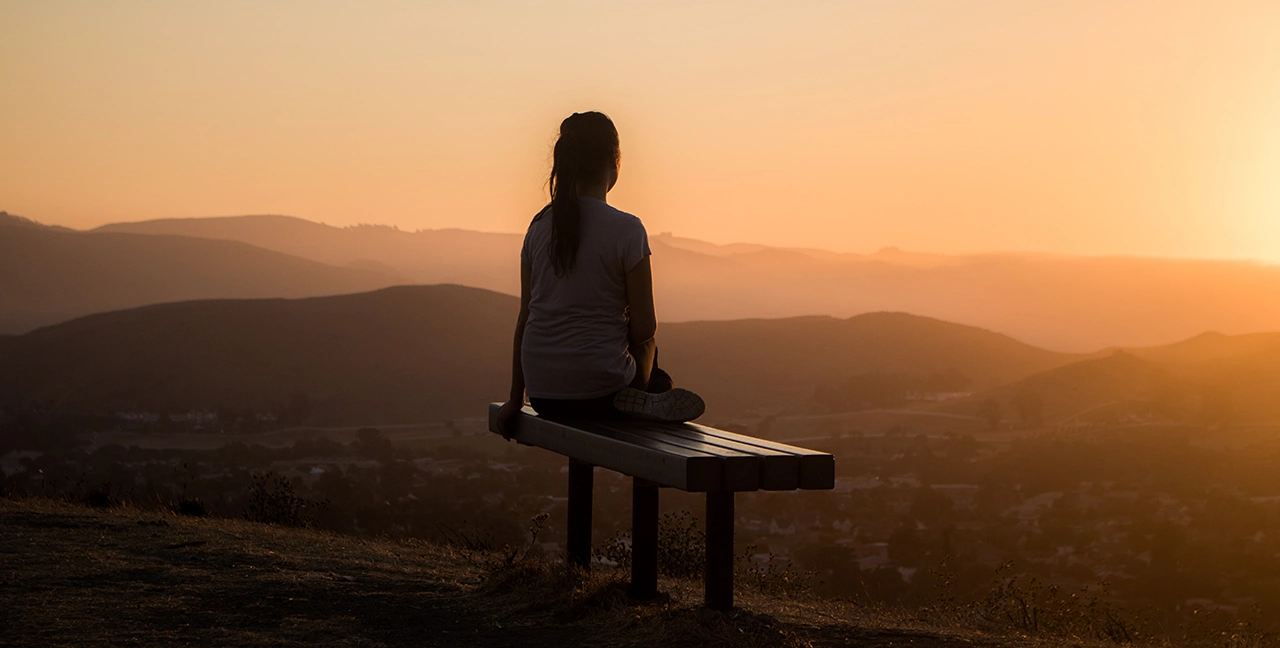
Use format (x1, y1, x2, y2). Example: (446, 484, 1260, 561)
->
(489, 403, 836, 610)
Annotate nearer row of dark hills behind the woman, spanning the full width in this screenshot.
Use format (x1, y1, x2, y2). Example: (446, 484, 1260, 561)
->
(0, 275, 1280, 426)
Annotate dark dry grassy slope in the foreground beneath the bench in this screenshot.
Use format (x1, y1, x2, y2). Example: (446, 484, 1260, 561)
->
(0, 498, 1111, 648)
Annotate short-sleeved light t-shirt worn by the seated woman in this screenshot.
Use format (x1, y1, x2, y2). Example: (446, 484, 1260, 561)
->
(520, 197, 650, 398)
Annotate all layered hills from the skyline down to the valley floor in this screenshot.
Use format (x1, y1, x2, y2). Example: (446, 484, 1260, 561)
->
(12, 214, 1280, 425)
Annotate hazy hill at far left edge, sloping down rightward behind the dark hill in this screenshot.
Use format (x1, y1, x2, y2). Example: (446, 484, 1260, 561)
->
(0, 214, 406, 333)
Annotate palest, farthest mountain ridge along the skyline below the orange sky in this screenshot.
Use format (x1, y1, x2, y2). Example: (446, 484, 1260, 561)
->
(101, 216, 1280, 352)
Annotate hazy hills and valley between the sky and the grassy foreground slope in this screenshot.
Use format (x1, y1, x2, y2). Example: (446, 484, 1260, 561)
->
(0, 210, 1280, 642)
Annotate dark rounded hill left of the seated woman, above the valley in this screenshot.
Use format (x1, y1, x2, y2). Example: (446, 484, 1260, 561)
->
(0, 286, 517, 423)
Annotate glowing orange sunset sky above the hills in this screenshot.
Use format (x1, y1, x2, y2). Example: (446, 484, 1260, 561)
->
(0, 0, 1280, 263)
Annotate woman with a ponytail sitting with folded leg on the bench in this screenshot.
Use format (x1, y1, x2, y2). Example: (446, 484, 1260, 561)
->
(497, 113, 704, 437)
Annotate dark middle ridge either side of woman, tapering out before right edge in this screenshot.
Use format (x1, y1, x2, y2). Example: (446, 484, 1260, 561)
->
(0, 286, 1078, 424)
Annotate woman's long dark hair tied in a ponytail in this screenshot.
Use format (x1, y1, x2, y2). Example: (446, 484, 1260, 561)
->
(548, 111, 622, 277)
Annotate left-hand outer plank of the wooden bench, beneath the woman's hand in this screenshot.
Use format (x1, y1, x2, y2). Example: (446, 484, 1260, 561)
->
(489, 403, 723, 492)
